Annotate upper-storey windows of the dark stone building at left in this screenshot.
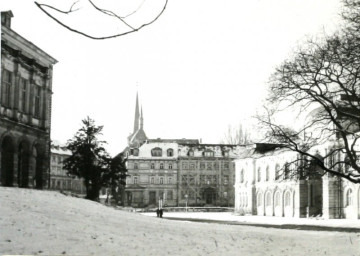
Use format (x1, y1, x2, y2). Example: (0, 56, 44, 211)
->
(1, 70, 41, 118)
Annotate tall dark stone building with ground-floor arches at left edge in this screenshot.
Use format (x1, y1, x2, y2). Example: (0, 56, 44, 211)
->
(0, 11, 57, 188)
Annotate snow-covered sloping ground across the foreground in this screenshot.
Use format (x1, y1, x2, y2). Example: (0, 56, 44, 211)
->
(0, 187, 360, 256)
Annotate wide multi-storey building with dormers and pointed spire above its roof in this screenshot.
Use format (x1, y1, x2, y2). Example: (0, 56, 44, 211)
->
(124, 93, 241, 207)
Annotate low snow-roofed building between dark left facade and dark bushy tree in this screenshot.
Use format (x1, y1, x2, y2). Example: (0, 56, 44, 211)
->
(50, 145, 86, 194)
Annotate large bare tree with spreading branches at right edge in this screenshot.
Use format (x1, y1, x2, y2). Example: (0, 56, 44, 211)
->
(259, 0, 360, 183)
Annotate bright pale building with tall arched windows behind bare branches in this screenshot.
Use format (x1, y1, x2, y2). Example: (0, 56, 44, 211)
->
(235, 141, 360, 219)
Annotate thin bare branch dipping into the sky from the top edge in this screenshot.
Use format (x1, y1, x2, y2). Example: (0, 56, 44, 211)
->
(35, 0, 168, 40)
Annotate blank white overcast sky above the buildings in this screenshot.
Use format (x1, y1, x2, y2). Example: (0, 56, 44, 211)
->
(0, 0, 341, 155)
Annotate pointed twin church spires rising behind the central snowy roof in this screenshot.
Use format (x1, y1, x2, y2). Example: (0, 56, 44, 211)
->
(128, 93, 148, 147)
